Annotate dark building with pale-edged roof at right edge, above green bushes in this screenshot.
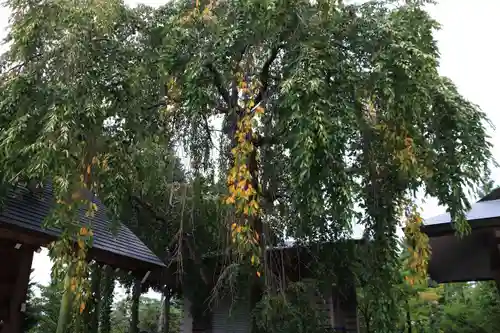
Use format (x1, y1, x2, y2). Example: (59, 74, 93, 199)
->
(423, 189, 500, 287)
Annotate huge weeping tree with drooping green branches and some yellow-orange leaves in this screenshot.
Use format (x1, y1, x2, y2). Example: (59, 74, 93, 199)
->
(0, 0, 491, 332)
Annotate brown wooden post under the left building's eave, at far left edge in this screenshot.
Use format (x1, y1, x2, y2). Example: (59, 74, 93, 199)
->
(2, 247, 33, 333)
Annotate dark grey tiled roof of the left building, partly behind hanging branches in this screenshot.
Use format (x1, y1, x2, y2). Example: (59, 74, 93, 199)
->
(0, 185, 165, 266)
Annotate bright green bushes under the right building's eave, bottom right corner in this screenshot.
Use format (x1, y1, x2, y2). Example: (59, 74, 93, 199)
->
(357, 241, 500, 333)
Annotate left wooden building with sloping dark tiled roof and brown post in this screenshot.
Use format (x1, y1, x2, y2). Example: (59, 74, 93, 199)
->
(0, 185, 165, 333)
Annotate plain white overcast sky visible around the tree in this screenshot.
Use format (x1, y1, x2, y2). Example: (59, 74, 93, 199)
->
(0, 0, 500, 297)
